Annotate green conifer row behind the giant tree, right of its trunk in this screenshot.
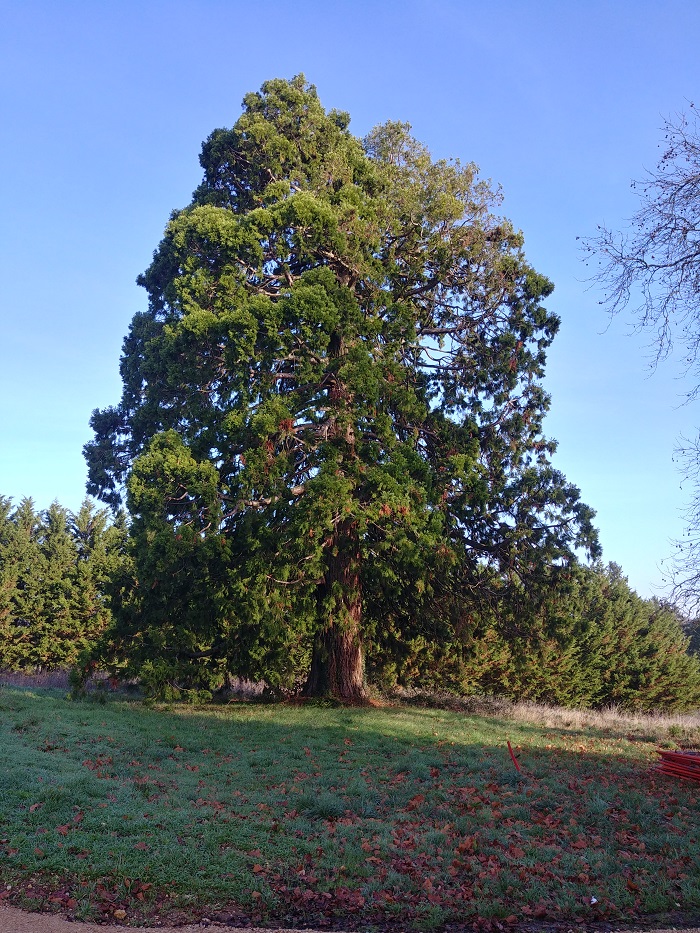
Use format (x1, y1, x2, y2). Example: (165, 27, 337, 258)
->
(370, 564, 700, 711)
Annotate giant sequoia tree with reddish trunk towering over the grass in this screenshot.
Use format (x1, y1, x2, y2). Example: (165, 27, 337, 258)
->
(86, 77, 596, 698)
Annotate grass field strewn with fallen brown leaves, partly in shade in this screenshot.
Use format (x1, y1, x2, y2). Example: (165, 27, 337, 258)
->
(0, 686, 700, 929)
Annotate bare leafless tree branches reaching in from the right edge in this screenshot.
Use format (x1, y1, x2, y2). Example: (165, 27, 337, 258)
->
(584, 103, 700, 612)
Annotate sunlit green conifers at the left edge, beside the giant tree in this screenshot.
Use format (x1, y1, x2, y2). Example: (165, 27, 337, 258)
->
(0, 497, 126, 670)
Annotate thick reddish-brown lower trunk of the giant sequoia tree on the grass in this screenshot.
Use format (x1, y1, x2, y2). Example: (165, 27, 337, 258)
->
(304, 522, 365, 703)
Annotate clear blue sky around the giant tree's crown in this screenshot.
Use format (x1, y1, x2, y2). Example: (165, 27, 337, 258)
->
(0, 0, 700, 595)
